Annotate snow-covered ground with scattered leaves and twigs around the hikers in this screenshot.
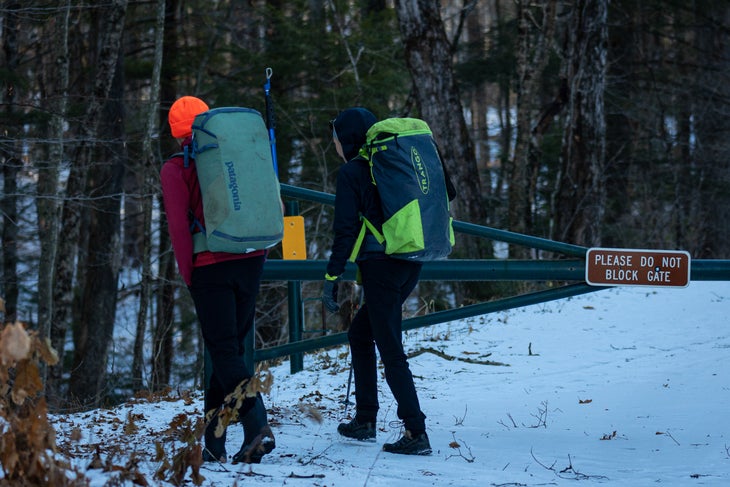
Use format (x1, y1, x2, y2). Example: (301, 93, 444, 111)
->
(51, 282, 730, 487)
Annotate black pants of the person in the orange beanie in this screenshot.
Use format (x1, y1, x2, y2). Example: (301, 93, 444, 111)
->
(190, 256, 265, 417)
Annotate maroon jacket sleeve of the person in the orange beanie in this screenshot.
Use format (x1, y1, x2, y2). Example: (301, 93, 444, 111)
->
(160, 161, 193, 286)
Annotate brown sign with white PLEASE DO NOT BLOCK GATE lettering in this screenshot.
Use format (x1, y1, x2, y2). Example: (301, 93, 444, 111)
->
(586, 248, 691, 287)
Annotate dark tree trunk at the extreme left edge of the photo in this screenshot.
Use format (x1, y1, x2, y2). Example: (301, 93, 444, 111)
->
(0, 1, 21, 321)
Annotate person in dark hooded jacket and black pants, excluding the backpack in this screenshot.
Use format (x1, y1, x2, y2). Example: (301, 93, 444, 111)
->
(322, 108, 431, 455)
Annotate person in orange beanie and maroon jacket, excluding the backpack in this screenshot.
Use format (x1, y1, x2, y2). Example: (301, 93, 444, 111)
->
(160, 96, 275, 463)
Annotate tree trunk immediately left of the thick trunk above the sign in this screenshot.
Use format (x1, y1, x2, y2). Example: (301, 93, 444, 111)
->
(507, 0, 557, 259)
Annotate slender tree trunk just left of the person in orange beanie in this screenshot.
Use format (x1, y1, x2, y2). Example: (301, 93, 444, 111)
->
(132, 0, 165, 388)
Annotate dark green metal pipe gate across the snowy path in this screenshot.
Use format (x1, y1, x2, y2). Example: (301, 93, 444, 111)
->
(249, 184, 730, 372)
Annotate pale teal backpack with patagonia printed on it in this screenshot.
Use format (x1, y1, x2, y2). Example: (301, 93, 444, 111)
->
(185, 107, 284, 254)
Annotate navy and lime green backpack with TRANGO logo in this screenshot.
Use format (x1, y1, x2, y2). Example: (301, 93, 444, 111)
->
(350, 118, 454, 261)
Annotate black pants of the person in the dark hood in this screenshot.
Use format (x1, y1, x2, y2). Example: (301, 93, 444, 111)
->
(348, 258, 426, 434)
